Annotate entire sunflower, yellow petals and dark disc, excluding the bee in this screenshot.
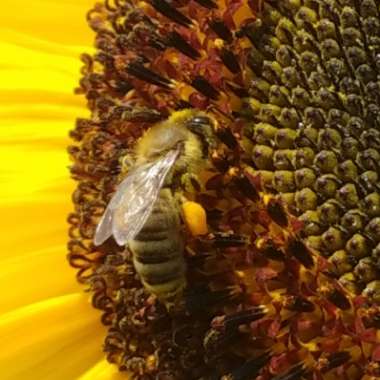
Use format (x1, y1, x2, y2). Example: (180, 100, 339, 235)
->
(0, 0, 380, 380)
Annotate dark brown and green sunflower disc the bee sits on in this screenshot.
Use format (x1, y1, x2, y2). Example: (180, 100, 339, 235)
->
(68, 0, 380, 380)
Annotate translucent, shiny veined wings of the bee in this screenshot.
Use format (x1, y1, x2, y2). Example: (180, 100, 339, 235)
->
(94, 150, 178, 245)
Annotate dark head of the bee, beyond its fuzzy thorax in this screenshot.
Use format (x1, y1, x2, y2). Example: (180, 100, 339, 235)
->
(186, 112, 217, 156)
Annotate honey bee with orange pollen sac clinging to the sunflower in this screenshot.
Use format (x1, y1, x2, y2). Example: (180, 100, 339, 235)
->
(94, 110, 216, 307)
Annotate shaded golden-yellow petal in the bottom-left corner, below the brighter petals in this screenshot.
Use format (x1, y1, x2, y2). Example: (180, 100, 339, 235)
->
(0, 294, 103, 380)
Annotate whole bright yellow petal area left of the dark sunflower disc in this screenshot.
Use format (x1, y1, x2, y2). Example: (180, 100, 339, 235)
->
(0, 0, 123, 380)
